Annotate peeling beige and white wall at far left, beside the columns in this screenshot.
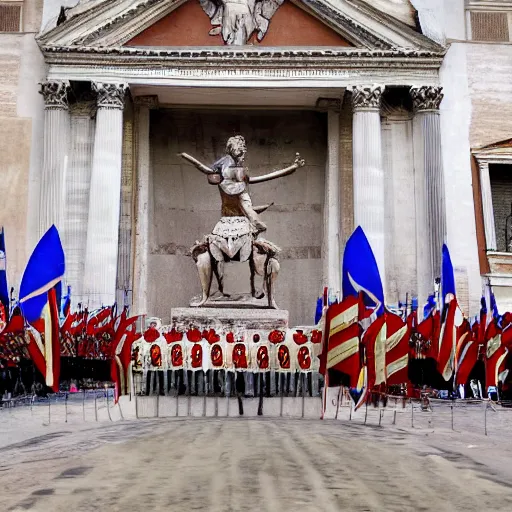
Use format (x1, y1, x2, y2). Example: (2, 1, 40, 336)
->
(0, 0, 46, 293)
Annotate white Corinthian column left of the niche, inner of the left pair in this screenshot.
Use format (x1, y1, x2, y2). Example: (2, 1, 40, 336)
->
(84, 83, 127, 309)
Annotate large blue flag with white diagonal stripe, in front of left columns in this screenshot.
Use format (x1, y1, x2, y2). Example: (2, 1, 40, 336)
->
(20, 226, 65, 323)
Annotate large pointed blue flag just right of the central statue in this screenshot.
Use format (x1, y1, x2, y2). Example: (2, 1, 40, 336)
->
(342, 226, 384, 315)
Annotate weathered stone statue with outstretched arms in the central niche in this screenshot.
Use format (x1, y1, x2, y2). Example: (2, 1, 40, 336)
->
(180, 135, 305, 308)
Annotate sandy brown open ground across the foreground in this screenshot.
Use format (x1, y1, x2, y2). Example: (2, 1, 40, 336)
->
(0, 412, 512, 512)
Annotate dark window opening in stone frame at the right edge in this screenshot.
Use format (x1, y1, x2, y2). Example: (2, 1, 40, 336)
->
(489, 164, 512, 252)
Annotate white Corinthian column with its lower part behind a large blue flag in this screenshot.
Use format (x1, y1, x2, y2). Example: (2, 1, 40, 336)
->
(352, 85, 386, 284)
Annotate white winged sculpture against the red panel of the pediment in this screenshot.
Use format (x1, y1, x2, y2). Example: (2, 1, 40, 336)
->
(199, 0, 284, 45)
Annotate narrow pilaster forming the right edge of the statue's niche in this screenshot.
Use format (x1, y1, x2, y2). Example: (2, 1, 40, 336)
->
(323, 105, 341, 297)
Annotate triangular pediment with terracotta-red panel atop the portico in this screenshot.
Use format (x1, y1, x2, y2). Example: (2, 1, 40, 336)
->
(38, 0, 443, 53)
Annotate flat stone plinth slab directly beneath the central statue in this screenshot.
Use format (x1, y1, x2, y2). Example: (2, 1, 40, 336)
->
(171, 307, 289, 331)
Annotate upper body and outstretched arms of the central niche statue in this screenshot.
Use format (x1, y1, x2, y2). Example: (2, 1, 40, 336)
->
(180, 135, 305, 234)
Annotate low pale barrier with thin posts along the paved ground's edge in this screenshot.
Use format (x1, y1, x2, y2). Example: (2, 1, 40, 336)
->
(4, 388, 512, 438)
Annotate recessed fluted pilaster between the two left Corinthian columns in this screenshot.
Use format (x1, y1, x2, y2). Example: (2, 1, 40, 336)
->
(62, 101, 95, 306)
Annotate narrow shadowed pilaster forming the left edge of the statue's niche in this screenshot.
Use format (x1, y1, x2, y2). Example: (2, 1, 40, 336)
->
(133, 96, 158, 314)
